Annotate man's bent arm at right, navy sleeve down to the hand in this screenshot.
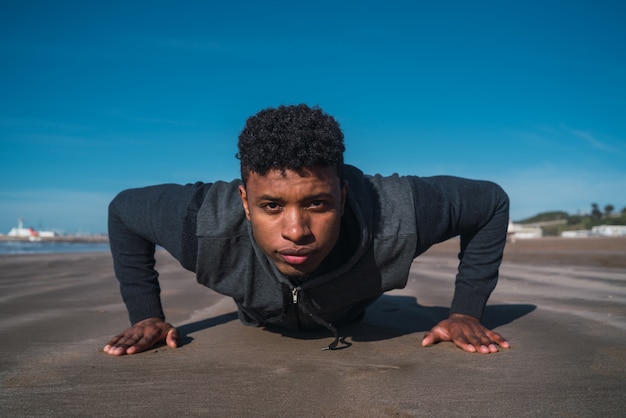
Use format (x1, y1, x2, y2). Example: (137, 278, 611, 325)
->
(414, 177, 509, 353)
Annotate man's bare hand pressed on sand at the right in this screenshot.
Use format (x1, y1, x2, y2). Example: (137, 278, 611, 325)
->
(422, 314, 510, 354)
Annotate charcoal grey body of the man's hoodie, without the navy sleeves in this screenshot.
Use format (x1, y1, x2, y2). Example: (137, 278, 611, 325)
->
(196, 166, 416, 342)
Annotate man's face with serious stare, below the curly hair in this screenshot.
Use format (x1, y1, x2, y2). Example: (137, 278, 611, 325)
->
(239, 167, 346, 276)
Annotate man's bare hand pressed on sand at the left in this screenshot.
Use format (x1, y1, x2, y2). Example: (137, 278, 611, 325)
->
(104, 318, 178, 356)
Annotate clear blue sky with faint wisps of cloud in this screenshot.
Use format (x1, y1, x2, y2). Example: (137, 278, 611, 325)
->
(0, 0, 626, 233)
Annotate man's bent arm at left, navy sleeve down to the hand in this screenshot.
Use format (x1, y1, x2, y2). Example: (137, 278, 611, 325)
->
(105, 184, 210, 355)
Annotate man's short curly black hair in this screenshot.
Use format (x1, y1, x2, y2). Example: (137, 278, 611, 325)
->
(236, 104, 345, 182)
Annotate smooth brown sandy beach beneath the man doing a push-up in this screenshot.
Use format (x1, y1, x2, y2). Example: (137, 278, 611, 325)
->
(0, 238, 626, 417)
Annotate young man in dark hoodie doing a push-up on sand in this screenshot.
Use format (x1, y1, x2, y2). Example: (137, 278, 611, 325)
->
(104, 105, 509, 355)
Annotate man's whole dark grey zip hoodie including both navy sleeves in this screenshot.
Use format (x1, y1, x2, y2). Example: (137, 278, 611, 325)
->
(109, 166, 509, 346)
